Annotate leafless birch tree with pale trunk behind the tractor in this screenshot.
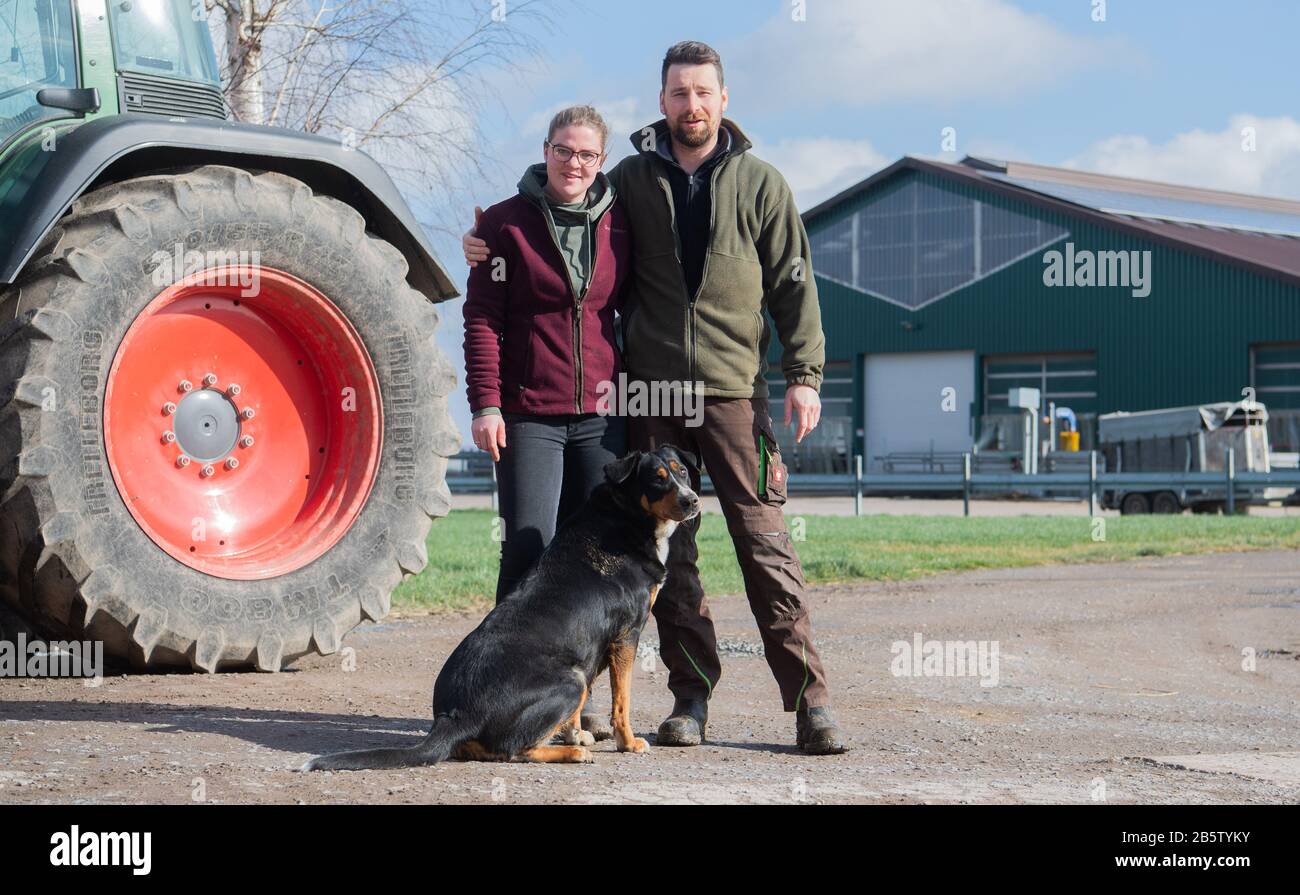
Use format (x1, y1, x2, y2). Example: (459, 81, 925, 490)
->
(204, 0, 551, 233)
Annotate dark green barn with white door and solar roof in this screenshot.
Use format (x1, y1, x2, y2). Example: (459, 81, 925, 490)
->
(770, 157, 1300, 472)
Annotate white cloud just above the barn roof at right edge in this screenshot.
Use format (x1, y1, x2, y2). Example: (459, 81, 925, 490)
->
(1065, 114, 1300, 198)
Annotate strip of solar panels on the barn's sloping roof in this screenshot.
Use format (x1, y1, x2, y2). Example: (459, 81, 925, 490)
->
(980, 172, 1300, 237)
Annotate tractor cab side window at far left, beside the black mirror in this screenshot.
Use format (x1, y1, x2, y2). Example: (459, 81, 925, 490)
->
(0, 0, 77, 146)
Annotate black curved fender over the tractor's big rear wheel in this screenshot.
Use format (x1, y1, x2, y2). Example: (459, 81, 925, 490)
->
(0, 113, 459, 302)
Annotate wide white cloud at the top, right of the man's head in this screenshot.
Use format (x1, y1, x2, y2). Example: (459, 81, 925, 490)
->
(720, 0, 1131, 107)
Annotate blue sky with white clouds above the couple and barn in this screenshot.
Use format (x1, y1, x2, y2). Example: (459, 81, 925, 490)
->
(426, 0, 1300, 445)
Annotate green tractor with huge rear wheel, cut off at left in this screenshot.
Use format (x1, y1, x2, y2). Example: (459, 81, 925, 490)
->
(0, 0, 460, 673)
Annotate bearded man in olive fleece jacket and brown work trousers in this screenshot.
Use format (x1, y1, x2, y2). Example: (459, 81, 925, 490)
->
(465, 42, 852, 755)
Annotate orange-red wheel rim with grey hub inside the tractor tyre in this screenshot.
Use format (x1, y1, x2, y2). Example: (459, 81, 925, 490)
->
(104, 265, 384, 580)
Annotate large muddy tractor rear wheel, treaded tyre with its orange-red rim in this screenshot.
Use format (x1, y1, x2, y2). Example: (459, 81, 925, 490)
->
(0, 165, 460, 673)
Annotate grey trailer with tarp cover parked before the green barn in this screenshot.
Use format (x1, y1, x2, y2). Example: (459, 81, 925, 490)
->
(1097, 401, 1279, 515)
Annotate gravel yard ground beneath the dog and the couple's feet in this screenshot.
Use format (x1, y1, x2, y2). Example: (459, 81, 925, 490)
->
(0, 552, 1300, 804)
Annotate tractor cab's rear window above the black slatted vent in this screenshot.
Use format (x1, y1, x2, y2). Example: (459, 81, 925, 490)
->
(108, 0, 221, 83)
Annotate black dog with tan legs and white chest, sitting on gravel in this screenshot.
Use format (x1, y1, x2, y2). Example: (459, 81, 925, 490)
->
(302, 445, 699, 770)
